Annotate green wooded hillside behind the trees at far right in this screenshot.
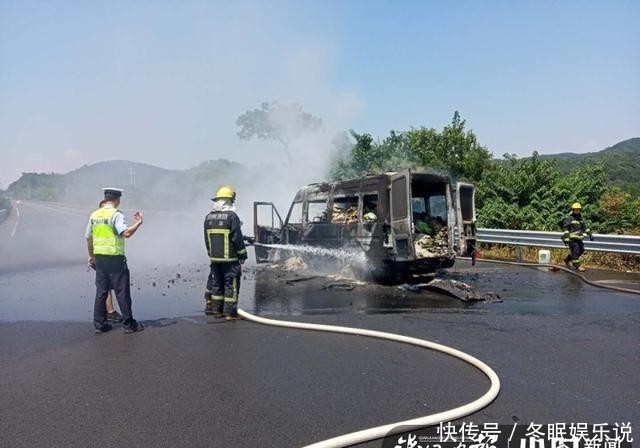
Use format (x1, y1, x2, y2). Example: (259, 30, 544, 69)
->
(540, 137, 640, 195)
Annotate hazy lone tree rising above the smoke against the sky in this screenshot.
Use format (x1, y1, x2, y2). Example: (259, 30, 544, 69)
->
(236, 101, 322, 162)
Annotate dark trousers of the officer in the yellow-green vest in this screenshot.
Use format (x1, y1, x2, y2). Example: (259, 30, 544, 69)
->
(93, 263, 136, 328)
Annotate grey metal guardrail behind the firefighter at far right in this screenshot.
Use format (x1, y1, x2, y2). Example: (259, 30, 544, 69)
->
(478, 229, 640, 255)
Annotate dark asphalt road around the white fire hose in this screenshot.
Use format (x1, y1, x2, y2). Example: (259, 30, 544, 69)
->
(0, 204, 640, 447)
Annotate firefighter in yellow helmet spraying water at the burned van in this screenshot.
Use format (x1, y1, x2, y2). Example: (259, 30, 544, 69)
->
(204, 186, 247, 320)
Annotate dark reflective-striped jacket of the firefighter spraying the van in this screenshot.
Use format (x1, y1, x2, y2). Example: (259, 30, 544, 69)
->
(204, 201, 247, 263)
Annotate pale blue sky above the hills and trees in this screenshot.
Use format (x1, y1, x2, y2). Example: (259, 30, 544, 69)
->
(0, 0, 640, 187)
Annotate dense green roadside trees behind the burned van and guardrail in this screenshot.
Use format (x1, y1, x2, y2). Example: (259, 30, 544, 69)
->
(330, 112, 640, 233)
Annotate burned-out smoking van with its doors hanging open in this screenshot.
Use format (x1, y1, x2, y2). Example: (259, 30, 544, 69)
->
(254, 170, 476, 280)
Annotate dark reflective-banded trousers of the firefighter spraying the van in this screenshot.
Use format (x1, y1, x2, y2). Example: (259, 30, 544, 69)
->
(205, 261, 242, 316)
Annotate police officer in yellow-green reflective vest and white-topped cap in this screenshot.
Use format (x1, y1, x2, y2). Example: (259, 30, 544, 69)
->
(86, 188, 144, 333)
